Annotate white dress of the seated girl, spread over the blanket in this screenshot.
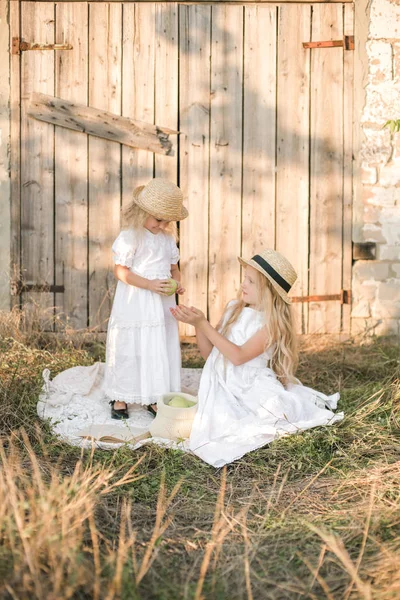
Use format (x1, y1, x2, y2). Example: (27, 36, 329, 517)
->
(189, 302, 343, 467)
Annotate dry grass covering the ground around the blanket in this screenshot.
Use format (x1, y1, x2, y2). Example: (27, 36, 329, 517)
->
(0, 315, 400, 600)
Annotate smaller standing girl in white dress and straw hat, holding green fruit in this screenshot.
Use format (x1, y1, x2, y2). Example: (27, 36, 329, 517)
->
(104, 178, 188, 419)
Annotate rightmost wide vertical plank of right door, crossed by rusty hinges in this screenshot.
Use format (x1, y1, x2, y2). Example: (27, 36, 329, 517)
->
(308, 4, 343, 333)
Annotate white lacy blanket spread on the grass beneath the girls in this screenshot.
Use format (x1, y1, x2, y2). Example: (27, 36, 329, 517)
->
(37, 362, 202, 450)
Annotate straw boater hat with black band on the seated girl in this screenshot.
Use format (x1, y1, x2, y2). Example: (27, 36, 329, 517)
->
(238, 248, 297, 304)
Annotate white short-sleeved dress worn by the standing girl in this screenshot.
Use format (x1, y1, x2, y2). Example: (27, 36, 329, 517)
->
(104, 229, 181, 404)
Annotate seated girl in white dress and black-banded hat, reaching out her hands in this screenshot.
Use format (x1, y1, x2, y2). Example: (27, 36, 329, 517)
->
(171, 249, 343, 467)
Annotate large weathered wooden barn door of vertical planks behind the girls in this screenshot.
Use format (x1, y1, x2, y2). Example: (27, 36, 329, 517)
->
(10, 1, 353, 335)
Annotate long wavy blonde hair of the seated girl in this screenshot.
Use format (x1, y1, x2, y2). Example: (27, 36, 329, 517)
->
(217, 270, 298, 385)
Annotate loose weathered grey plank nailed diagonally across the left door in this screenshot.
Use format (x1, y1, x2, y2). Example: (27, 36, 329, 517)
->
(28, 92, 176, 154)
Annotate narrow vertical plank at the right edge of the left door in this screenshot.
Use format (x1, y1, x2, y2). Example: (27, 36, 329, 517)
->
(154, 2, 178, 183)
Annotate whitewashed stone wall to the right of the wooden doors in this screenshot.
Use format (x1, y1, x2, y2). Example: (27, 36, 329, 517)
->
(352, 0, 400, 335)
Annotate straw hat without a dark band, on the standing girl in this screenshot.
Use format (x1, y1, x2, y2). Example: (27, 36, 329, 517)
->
(133, 177, 189, 221)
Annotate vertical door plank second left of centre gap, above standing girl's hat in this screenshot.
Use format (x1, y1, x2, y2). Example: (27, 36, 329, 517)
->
(122, 4, 155, 213)
